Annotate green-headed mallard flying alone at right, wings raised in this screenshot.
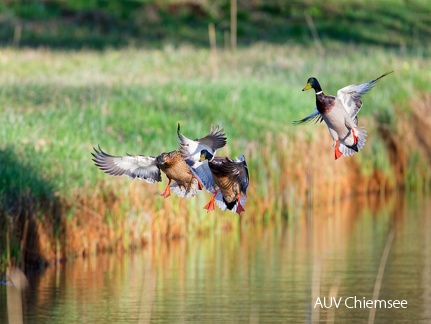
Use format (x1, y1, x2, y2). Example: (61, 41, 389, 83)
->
(294, 71, 393, 160)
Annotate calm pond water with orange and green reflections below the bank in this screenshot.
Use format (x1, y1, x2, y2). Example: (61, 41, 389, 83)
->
(0, 197, 431, 323)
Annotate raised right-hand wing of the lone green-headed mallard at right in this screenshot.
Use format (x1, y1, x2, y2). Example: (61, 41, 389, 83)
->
(337, 71, 394, 118)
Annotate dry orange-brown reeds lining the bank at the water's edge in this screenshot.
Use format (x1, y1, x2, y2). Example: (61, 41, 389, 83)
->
(3, 96, 431, 268)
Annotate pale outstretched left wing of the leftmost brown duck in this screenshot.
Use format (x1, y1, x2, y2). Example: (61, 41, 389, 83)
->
(91, 146, 162, 183)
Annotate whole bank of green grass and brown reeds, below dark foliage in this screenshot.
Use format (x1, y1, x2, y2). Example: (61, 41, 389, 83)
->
(0, 43, 431, 268)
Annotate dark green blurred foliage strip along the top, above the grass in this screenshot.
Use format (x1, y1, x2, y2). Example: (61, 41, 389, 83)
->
(0, 0, 431, 49)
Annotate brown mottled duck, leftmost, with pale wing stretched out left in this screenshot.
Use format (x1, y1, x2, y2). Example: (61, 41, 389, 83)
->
(91, 146, 202, 198)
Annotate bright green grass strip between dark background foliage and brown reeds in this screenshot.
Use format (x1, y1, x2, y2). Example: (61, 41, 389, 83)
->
(0, 45, 430, 194)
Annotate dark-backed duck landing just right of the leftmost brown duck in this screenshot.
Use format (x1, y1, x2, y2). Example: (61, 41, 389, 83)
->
(200, 150, 249, 214)
